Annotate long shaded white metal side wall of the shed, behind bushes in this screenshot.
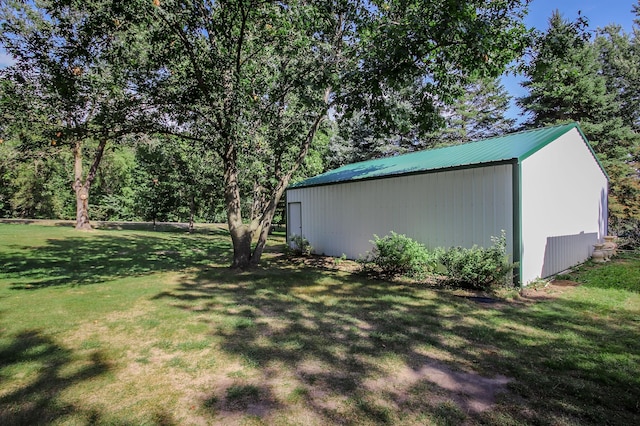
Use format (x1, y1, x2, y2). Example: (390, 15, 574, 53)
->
(287, 165, 513, 259)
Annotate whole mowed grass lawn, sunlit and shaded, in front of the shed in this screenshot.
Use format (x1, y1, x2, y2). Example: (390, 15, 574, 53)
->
(0, 224, 640, 425)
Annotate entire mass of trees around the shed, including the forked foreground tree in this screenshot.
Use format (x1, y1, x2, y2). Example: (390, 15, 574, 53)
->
(0, 0, 640, 267)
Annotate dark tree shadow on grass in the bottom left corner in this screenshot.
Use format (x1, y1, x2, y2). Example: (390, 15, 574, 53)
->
(0, 330, 109, 425)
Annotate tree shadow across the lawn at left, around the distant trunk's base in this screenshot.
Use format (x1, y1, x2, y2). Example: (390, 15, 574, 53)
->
(0, 231, 230, 290)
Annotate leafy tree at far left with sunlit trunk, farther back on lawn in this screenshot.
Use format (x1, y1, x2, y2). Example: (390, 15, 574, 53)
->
(0, 0, 141, 229)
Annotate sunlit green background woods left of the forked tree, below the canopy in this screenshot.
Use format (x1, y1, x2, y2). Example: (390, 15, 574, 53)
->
(0, 138, 225, 222)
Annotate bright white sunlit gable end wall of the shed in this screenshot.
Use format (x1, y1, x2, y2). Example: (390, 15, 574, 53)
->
(521, 129, 607, 284)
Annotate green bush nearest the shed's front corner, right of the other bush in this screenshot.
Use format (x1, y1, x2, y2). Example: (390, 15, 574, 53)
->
(440, 231, 515, 289)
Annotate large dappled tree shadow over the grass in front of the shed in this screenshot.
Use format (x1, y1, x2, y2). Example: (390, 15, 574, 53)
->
(156, 263, 640, 424)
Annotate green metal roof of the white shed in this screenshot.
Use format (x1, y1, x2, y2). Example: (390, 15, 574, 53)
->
(289, 123, 606, 188)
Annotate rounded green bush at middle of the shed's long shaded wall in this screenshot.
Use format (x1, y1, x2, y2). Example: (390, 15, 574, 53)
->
(362, 231, 438, 277)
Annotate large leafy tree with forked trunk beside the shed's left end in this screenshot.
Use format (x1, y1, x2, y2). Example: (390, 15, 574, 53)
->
(136, 0, 528, 268)
